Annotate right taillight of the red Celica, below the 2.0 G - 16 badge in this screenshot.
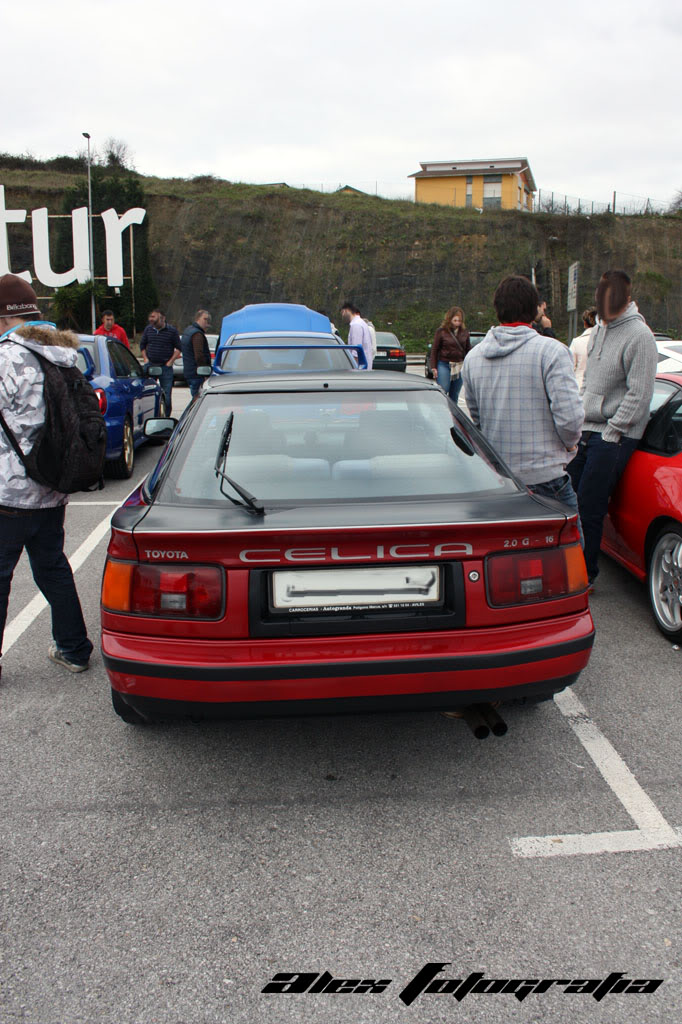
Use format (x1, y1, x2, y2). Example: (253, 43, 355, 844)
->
(485, 544, 587, 607)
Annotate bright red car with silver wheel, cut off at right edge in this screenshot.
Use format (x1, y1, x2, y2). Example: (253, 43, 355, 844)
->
(601, 373, 682, 640)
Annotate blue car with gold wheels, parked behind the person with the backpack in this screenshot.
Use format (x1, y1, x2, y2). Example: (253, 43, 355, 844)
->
(77, 335, 166, 480)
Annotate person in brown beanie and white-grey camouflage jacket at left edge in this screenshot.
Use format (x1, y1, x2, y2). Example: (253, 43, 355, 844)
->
(0, 273, 96, 672)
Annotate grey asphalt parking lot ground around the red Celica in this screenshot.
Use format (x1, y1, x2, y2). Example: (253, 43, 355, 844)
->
(0, 390, 682, 1024)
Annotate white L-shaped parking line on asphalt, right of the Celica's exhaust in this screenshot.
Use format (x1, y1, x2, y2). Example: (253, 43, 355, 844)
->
(510, 689, 682, 857)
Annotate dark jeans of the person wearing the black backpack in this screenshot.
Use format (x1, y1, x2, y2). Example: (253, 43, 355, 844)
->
(0, 505, 92, 665)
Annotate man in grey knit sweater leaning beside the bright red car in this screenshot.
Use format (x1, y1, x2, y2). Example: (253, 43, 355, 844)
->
(568, 270, 657, 585)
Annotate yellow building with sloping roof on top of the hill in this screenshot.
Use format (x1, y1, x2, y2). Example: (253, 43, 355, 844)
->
(410, 157, 537, 210)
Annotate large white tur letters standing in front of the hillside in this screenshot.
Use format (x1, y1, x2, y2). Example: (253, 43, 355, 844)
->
(0, 185, 146, 288)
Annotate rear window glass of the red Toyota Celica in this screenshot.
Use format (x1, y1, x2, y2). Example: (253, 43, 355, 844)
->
(156, 391, 518, 505)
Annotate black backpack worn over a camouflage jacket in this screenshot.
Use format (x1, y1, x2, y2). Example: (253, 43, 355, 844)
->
(0, 348, 106, 495)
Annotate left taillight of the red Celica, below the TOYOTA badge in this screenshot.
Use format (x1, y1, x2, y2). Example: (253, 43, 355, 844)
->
(101, 560, 223, 618)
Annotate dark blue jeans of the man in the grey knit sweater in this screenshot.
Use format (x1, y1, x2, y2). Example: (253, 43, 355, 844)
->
(568, 430, 639, 581)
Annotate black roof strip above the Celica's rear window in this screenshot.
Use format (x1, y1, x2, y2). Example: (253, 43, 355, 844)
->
(201, 370, 442, 395)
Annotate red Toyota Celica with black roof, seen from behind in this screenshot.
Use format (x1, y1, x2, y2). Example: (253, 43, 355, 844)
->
(101, 371, 594, 722)
